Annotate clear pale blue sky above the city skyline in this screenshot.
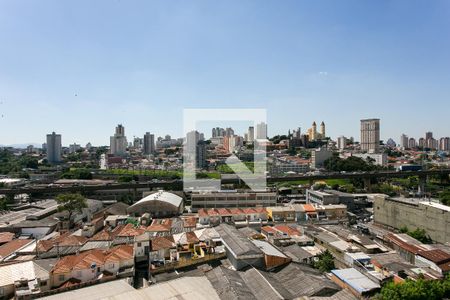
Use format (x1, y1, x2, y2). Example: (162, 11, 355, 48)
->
(0, 0, 450, 145)
